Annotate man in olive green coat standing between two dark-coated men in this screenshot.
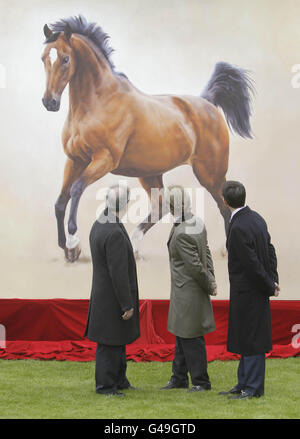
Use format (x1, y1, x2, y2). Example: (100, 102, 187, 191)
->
(162, 186, 217, 392)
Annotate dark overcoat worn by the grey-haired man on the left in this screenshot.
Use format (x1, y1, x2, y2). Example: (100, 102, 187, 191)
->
(84, 210, 140, 346)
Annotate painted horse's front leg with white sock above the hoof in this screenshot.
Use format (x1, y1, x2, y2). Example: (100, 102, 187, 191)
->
(65, 149, 114, 262)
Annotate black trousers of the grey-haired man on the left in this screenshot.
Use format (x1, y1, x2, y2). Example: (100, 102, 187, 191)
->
(95, 343, 130, 393)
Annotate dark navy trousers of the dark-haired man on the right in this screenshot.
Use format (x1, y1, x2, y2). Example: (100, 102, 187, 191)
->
(237, 354, 266, 396)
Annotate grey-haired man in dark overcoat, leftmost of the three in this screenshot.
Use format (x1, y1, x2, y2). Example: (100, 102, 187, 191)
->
(84, 186, 140, 396)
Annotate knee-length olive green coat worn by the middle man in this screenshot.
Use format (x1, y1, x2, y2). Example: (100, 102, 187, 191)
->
(168, 216, 216, 338)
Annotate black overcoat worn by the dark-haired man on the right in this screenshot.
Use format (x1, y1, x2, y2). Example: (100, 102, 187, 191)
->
(227, 206, 278, 355)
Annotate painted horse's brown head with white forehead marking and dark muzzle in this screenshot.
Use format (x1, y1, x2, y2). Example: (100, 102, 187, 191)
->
(42, 24, 75, 111)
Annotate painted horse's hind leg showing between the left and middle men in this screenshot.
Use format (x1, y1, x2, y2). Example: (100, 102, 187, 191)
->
(131, 175, 169, 259)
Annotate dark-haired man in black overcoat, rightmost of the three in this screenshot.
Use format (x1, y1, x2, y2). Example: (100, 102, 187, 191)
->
(220, 181, 280, 399)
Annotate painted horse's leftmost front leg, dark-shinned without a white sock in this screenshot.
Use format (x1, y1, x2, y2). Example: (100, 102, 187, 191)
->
(55, 158, 88, 249)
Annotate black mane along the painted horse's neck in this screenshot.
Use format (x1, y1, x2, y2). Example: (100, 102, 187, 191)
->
(45, 15, 116, 72)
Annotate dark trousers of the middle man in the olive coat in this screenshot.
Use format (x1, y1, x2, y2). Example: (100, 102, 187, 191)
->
(171, 337, 211, 389)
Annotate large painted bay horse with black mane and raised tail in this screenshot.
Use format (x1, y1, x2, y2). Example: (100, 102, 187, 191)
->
(42, 15, 254, 262)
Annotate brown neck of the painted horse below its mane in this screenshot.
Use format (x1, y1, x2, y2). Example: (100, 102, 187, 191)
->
(69, 38, 116, 114)
